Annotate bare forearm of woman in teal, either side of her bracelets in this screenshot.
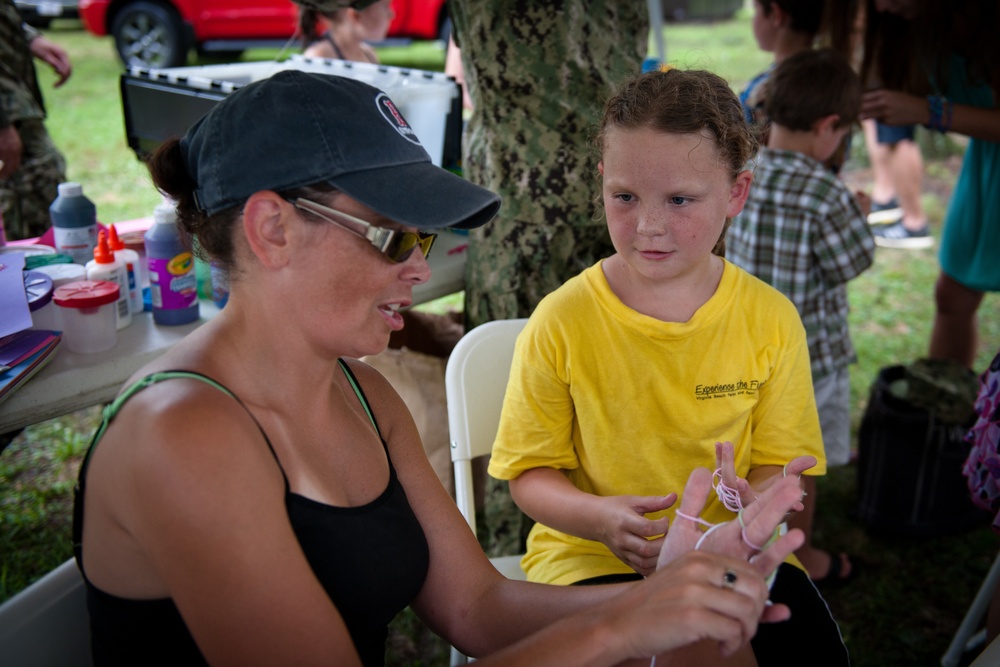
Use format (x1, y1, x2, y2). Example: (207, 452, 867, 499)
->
(861, 89, 1000, 142)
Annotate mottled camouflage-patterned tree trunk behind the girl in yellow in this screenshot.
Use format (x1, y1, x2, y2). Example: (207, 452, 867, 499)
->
(448, 0, 649, 555)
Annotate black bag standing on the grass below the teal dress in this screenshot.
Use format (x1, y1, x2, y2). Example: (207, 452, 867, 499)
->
(857, 360, 989, 537)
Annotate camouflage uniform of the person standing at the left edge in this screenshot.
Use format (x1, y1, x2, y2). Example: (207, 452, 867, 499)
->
(0, 0, 66, 240)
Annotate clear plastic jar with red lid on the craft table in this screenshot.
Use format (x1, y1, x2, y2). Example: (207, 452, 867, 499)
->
(52, 280, 121, 353)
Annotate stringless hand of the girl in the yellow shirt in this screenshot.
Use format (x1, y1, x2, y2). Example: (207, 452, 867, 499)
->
(598, 493, 677, 576)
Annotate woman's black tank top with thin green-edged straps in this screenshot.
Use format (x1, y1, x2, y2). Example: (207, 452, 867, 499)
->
(73, 360, 429, 667)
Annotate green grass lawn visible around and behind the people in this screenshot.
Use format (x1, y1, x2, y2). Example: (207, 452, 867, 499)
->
(7, 11, 1000, 667)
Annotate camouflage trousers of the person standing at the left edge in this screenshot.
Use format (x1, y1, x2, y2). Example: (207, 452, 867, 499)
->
(0, 120, 66, 241)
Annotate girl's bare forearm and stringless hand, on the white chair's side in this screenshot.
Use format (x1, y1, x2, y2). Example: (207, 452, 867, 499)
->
(510, 468, 677, 575)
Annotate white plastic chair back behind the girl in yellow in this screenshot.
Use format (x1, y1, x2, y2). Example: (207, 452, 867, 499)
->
(445, 319, 528, 532)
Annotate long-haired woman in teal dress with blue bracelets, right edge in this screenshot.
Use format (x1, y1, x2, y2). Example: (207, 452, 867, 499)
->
(861, 0, 1000, 368)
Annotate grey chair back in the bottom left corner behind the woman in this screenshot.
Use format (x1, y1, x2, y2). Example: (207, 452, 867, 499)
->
(0, 558, 93, 667)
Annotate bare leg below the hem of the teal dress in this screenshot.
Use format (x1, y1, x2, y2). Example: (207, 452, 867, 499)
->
(930, 273, 983, 368)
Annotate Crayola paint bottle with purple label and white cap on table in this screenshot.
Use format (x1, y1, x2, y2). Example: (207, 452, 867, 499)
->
(143, 201, 199, 325)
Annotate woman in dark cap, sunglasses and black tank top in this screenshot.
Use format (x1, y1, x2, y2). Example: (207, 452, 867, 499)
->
(74, 72, 801, 666)
